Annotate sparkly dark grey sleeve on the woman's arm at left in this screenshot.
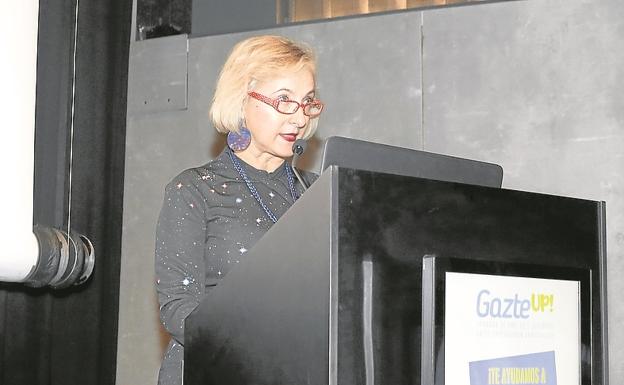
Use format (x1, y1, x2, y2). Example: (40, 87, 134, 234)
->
(155, 171, 206, 344)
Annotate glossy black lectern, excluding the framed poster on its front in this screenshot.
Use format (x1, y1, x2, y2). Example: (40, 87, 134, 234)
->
(184, 166, 607, 385)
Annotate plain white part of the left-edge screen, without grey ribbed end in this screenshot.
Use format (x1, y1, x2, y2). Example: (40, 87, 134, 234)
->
(0, 0, 39, 282)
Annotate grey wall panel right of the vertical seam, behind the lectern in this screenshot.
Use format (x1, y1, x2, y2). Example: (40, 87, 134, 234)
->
(423, 0, 624, 383)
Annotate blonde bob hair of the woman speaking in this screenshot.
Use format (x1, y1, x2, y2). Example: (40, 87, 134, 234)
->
(210, 35, 318, 139)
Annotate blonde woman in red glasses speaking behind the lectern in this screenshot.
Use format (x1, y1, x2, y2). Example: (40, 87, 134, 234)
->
(156, 36, 323, 384)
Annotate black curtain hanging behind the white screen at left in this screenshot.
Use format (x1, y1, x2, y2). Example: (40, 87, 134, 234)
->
(0, 0, 132, 385)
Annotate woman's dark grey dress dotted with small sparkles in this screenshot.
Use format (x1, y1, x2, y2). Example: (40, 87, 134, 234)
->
(155, 148, 316, 385)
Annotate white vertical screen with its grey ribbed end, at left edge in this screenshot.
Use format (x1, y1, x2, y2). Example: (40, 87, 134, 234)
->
(0, 0, 95, 289)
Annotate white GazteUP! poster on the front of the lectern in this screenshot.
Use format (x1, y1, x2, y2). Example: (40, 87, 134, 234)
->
(444, 272, 581, 385)
